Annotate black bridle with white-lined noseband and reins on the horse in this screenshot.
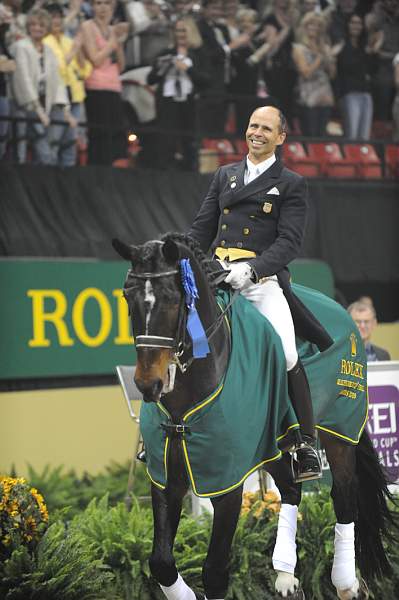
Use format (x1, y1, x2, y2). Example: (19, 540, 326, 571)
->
(123, 269, 239, 373)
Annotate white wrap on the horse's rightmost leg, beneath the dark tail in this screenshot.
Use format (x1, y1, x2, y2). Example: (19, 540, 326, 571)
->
(331, 523, 356, 590)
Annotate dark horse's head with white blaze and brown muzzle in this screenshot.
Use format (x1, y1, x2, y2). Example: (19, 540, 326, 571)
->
(112, 239, 183, 402)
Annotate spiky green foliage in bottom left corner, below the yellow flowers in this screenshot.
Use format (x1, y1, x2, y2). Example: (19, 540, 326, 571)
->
(0, 523, 115, 600)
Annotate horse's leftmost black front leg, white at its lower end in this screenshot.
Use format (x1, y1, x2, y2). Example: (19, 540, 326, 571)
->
(149, 485, 196, 600)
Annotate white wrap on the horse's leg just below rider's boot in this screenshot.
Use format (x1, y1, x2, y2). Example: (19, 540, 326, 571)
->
(273, 504, 298, 575)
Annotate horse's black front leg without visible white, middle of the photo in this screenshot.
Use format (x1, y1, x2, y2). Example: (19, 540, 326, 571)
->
(202, 486, 243, 600)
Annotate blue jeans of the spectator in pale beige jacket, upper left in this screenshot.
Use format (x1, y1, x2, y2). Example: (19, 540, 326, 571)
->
(13, 106, 55, 165)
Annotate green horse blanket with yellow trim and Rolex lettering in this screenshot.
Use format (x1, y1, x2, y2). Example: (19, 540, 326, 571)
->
(140, 285, 367, 497)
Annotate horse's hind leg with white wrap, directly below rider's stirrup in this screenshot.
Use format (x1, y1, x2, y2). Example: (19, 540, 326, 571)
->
(267, 453, 305, 600)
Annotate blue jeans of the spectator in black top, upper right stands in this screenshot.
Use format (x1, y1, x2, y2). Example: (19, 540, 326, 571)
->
(341, 92, 373, 141)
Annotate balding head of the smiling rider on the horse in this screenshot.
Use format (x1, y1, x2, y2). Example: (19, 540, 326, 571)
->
(245, 106, 285, 164)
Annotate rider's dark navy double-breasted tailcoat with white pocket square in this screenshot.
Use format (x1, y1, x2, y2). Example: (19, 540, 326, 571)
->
(189, 159, 332, 350)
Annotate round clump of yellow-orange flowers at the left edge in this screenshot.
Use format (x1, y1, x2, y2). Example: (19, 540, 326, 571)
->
(0, 476, 48, 559)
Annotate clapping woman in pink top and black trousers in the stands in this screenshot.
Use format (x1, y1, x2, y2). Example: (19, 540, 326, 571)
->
(81, 0, 126, 165)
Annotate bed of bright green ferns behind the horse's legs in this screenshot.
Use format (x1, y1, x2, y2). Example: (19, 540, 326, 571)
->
(0, 463, 399, 600)
